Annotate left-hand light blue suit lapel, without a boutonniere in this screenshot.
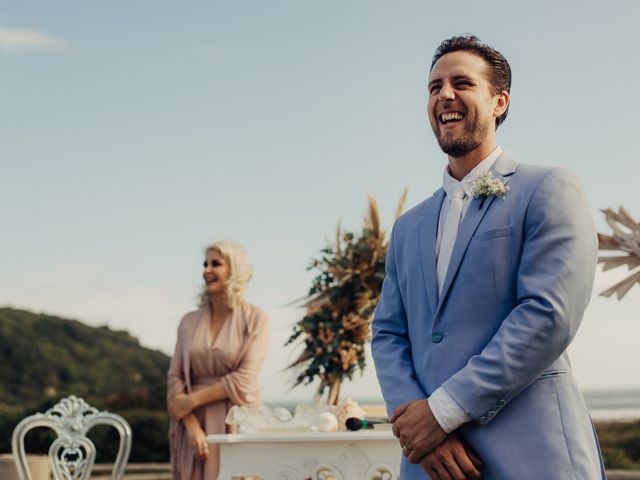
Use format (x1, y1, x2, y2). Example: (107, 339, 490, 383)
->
(419, 188, 445, 313)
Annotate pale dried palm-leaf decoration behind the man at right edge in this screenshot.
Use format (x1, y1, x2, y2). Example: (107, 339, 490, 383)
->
(598, 207, 640, 300)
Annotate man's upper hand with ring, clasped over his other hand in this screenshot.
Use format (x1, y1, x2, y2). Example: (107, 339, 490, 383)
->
(389, 398, 447, 463)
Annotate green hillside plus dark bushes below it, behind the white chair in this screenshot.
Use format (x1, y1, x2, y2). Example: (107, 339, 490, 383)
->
(0, 308, 169, 461)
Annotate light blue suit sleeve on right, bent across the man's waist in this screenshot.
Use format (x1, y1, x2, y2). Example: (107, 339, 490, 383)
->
(443, 169, 597, 424)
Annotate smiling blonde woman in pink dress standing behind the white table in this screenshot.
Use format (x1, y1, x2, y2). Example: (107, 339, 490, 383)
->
(167, 242, 268, 480)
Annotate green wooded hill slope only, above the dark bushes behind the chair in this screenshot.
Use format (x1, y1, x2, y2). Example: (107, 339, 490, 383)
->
(0, 308, 169, 410)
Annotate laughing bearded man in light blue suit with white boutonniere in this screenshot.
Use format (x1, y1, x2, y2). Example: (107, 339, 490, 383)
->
(372, 36, 605, 480)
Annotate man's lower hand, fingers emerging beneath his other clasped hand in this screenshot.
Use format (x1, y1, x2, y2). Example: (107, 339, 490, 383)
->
(420, 432, 483, 480)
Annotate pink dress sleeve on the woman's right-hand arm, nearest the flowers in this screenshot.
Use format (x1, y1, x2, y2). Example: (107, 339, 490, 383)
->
(220, 307, 269, 405)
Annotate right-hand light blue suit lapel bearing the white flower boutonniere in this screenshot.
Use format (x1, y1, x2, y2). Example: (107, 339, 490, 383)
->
(436, 152, 518, 317)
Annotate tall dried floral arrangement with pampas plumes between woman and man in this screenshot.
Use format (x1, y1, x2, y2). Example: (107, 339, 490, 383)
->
(285, 190, 407, 405)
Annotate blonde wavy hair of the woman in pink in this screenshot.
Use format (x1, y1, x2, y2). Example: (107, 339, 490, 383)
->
(200, 242, 253, 309)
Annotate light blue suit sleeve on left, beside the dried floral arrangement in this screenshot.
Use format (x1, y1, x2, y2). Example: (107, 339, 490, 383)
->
(371, 223, 427, 415)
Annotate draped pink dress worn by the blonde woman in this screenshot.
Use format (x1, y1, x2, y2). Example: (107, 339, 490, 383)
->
(167, 302, 268, 480)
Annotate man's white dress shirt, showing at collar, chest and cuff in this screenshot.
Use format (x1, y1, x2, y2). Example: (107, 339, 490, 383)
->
(428, 146, 502, 433)
